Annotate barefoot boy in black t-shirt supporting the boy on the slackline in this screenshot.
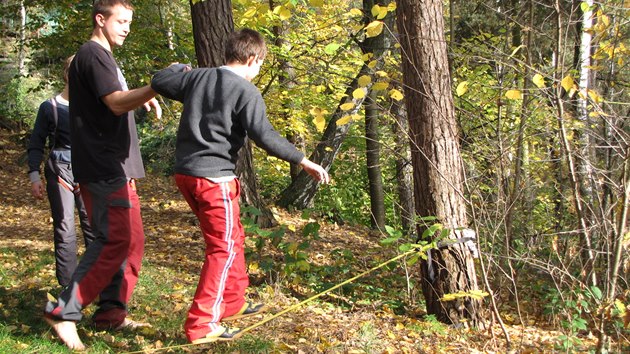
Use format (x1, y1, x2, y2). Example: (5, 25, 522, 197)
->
(44, 0, 161, 350)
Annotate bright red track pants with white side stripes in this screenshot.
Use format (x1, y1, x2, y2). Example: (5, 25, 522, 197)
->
(175, 174, 249, 341)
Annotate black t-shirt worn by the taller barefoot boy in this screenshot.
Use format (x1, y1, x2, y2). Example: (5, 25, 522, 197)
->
(68, 41, 144, 183)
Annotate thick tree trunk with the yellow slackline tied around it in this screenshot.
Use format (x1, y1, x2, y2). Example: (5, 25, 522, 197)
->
(396, 0, 482, 326)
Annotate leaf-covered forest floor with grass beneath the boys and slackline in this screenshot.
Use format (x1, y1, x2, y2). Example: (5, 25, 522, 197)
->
(0, 131, 612, 353)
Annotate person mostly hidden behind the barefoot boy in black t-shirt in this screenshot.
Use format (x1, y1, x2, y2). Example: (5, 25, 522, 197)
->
(27, 55, 94, 287)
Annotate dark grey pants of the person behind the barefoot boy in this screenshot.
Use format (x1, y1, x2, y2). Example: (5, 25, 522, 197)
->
(44, 161, 94, 287)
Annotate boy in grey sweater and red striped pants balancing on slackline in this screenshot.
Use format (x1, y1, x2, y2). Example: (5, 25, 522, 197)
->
(151, 29, 330, 344)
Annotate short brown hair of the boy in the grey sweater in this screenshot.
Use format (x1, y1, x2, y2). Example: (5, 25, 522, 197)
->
(225, 28, 267, 64)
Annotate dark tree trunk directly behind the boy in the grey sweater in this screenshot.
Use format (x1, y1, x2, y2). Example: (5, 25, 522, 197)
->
(190, 0, 275, 227)
